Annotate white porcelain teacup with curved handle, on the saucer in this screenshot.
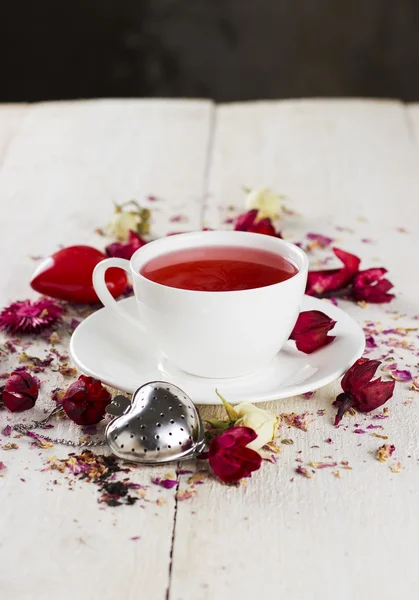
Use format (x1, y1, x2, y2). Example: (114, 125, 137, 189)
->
(93, 231, 308, 378)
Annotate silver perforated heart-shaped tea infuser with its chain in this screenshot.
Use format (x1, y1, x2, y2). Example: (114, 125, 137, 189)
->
(14, 381, 205, 465)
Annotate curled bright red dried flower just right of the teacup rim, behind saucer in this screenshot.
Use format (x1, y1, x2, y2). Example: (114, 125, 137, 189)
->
(306, 248, 361, 296)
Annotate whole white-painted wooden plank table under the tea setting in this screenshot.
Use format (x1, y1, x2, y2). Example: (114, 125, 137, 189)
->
(0, 100, 419, 600)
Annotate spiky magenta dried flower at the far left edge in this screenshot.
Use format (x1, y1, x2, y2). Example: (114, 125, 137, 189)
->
(0, 298, 63, 333)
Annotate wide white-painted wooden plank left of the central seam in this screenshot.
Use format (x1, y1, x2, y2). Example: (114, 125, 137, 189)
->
(0, 100, 212, 600)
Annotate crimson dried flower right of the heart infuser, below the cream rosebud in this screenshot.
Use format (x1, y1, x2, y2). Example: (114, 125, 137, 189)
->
(208, 427, 262, 483)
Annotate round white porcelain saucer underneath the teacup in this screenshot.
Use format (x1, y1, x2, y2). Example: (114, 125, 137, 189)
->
(70, 296, 365, 404)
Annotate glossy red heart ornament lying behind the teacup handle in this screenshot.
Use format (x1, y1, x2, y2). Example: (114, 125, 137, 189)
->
(31, 246, 127, 304)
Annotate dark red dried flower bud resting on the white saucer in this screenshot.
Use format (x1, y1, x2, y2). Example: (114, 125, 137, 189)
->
(289, 310, 336, 354)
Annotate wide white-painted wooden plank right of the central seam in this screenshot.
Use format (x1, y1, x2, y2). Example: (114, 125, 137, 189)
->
(170, 101, 419, 600)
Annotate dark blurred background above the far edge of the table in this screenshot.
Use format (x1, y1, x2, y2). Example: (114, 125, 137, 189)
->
(0, 0, 419, 102)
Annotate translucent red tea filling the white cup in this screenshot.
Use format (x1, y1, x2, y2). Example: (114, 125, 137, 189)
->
(140, 246, 298, 292)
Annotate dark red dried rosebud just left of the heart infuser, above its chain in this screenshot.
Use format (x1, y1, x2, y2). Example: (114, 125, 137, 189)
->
(61, 375, 111, 425)
